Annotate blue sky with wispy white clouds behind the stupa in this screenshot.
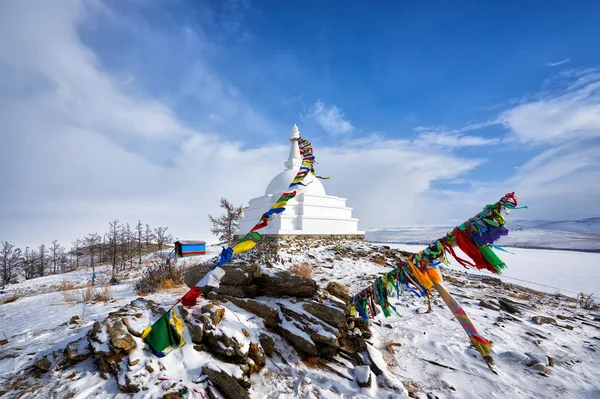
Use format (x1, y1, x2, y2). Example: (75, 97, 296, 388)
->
(0, 0, 600, 247)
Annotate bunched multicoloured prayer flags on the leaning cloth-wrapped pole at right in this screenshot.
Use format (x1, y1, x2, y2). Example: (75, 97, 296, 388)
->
(349, 192, 527, 371)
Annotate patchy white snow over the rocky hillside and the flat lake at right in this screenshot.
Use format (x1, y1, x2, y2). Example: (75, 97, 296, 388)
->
(0, 243, 600, 399)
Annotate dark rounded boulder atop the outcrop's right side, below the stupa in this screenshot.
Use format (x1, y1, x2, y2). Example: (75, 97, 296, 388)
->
(257, 270, 317, 297)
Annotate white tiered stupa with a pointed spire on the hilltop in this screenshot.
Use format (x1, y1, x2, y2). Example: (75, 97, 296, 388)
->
(239, 125, 365, 236)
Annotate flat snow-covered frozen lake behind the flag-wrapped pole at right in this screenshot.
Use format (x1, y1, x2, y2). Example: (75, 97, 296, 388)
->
(381, 243, 600, 297)
